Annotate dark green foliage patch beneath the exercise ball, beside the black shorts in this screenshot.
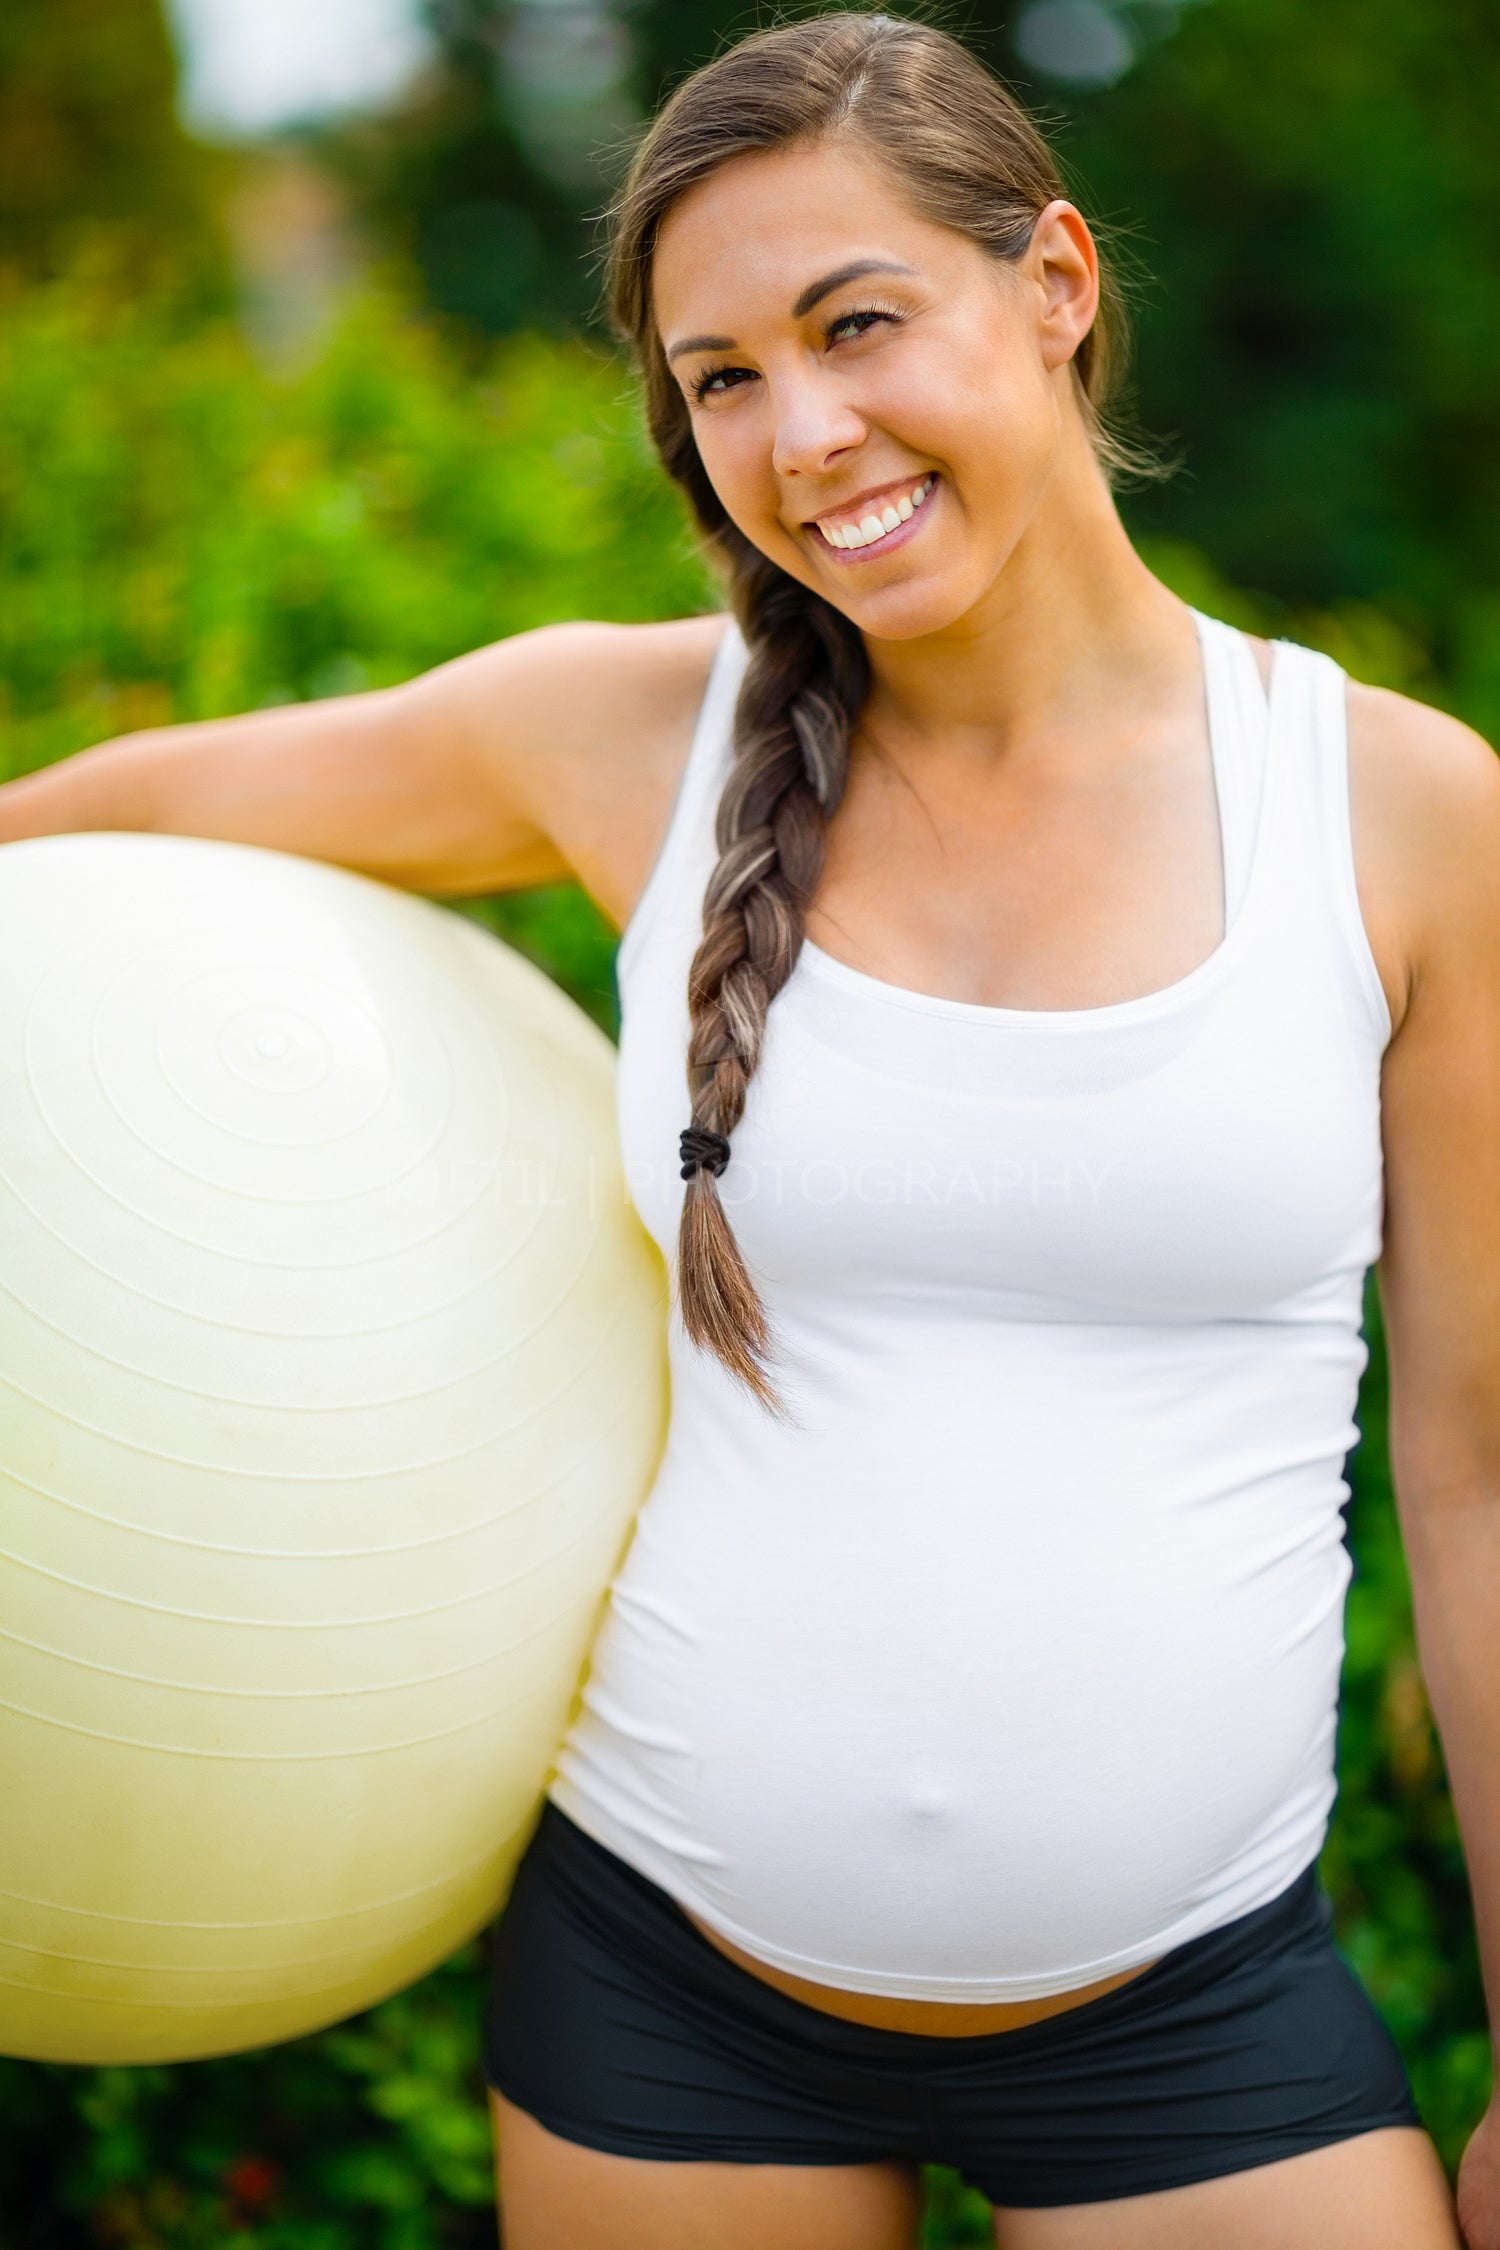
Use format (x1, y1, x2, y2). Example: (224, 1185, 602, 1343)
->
(0, 1946, 495, 2250)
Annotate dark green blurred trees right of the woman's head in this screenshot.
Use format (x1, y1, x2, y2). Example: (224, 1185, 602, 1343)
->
(1065, 0, 1500, 675)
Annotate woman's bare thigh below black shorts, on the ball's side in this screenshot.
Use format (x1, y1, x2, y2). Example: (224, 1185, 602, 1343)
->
(490, 2095, 926, 2250)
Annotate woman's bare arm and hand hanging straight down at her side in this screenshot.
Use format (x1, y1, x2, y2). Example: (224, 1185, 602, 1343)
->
(1370, 698, 1500, 2250)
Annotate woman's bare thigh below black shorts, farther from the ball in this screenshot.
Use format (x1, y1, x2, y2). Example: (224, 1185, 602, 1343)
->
(994, 2129, 1460, 2250)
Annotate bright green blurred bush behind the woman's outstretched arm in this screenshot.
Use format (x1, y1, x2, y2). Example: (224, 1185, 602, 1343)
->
(0, 261, 713, 1026)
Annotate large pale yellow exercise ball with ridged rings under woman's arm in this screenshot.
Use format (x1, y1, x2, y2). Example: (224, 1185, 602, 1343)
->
(0, 835, 666, 2063)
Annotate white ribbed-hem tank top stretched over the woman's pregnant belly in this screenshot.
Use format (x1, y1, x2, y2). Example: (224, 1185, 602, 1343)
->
(551, 617, 1390, 2000)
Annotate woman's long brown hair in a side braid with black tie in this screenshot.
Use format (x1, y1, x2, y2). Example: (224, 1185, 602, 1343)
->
(609, 11, 1142, 1411)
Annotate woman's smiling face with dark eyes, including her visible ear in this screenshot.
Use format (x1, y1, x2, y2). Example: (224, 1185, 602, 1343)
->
(652, 142, 1097, 639)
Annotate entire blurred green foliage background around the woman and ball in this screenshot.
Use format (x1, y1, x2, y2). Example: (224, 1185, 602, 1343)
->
(0, 0, 1500, 2250)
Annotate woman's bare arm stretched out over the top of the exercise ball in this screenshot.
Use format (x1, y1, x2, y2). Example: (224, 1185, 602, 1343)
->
(0, 617, 724, 923)
